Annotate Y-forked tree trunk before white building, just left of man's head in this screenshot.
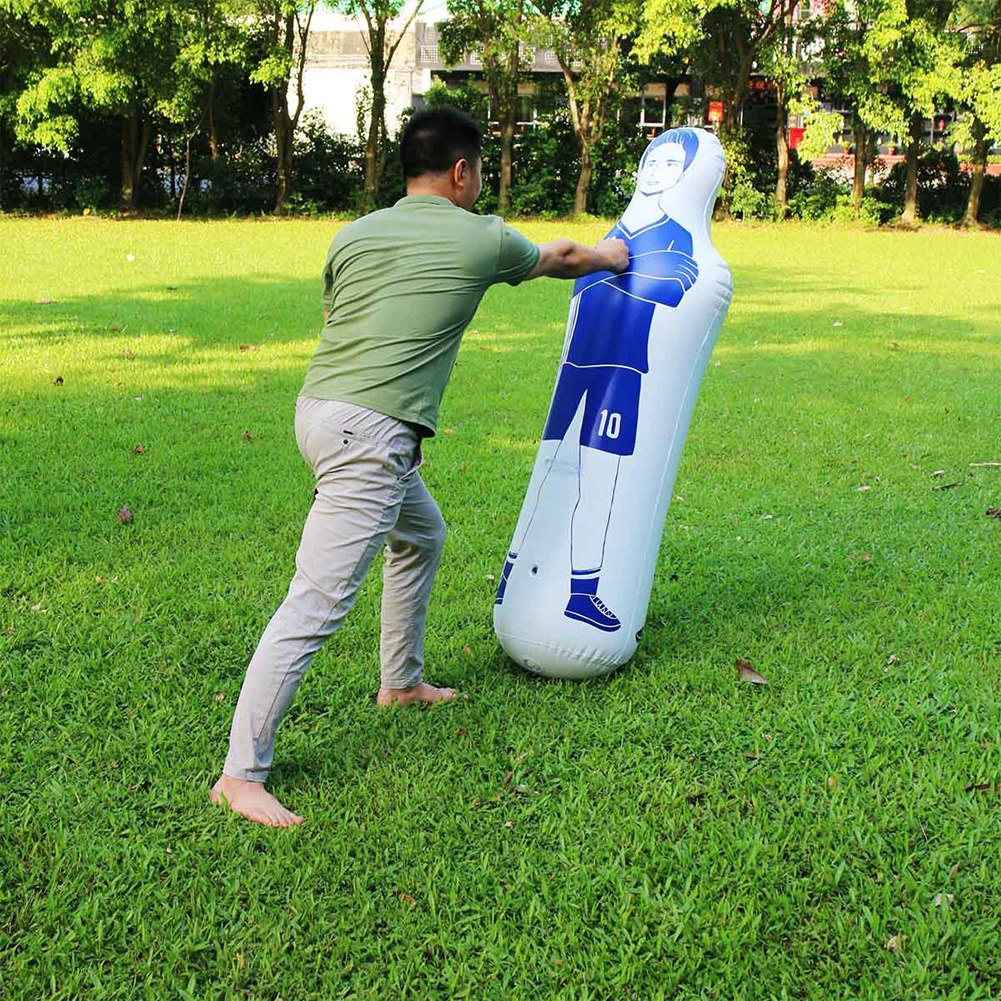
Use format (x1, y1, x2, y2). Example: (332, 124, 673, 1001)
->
(337, 0, 423, 210)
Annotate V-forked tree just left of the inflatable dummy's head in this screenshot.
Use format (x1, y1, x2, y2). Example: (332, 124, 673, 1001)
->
(537, 0, 641, 213)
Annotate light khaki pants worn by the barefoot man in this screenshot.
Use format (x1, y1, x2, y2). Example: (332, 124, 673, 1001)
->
(229, 397, 444, 782)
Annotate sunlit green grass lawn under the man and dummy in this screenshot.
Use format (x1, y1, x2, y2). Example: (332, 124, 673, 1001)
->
(0, 219, 1001, 1001)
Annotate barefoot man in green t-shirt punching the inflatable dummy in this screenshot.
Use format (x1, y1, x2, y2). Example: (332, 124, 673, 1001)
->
(211, 108, 629, 827)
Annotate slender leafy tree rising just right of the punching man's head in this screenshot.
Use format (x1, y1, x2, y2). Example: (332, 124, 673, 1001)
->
(440, 0, 531, 215)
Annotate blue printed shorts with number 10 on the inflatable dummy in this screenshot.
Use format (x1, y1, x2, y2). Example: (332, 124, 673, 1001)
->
(543, 364, 643, 455)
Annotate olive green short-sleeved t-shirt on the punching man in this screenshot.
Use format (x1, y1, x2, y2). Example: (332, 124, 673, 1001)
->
(302, 195, 539, 434)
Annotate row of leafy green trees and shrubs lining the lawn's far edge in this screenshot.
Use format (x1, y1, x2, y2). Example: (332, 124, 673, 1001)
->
(0, 0, 1001, 224)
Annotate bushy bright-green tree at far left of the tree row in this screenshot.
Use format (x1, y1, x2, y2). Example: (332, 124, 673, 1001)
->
(5, 0, 177, 209)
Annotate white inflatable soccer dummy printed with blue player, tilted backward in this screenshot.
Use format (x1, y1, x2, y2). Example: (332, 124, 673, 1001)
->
(493, 128, 732, 678)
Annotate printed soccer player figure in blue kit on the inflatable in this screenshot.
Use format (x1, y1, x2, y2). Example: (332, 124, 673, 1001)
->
(495, 128, 699, 633)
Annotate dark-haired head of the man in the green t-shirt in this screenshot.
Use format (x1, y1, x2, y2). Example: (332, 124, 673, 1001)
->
(399, 107, 482, 209)
